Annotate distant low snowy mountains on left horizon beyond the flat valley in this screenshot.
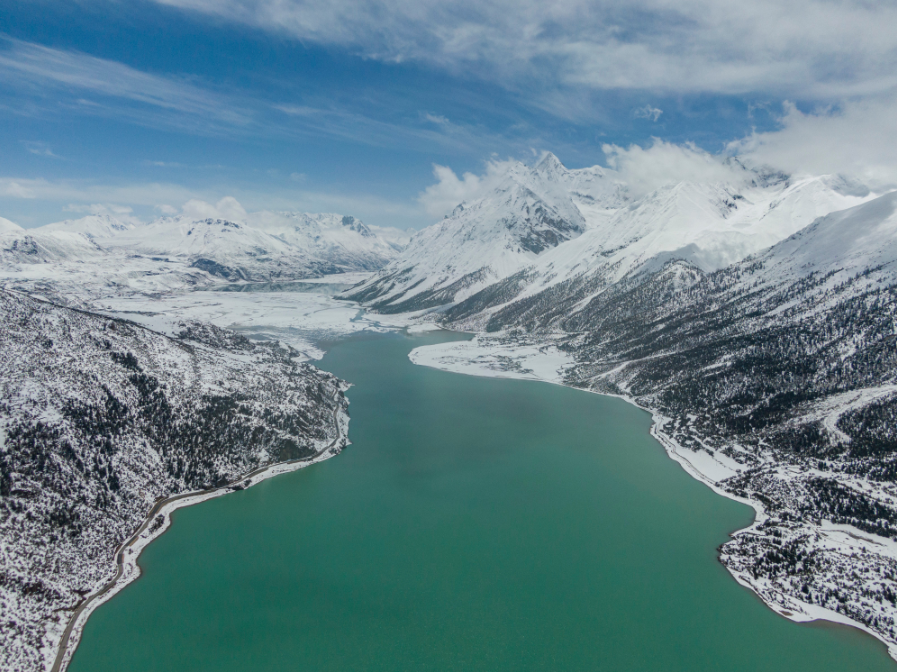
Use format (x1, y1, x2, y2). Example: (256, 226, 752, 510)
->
(0, 211, 407, 296)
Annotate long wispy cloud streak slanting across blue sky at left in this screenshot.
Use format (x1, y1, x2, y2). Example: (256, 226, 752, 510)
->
(0, 36, 532, 157)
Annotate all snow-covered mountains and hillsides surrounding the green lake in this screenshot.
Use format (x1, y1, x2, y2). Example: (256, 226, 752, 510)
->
(0, 153, 897, 669)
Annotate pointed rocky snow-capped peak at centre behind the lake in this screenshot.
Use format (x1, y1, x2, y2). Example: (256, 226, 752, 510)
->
(347, 153, 625, 312)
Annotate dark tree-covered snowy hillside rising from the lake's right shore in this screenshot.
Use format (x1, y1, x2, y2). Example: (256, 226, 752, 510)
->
(428, 189, 897, 654)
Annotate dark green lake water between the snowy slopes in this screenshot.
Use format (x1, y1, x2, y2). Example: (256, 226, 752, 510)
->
(70, 335, 895, 672)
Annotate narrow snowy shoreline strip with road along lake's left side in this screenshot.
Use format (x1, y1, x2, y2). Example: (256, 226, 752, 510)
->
(47, 394, 349, 672)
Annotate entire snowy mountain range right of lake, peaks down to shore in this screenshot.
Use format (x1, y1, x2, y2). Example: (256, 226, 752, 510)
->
(346, 156, 897, 651)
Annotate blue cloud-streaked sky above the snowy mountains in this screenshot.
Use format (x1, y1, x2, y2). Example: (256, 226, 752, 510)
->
(0, 0, 897, 228)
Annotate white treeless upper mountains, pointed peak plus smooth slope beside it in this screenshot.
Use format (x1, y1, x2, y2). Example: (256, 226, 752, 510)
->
(348, 154, 874, 312)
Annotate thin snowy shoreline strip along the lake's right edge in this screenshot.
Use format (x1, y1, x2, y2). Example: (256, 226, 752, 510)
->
(408, 329, 897, 662)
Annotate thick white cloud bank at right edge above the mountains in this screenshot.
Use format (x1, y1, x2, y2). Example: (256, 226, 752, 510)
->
(729, 93, 897, 187)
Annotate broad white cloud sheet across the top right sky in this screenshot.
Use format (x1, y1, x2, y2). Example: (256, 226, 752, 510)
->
(157, 0, 897, 98)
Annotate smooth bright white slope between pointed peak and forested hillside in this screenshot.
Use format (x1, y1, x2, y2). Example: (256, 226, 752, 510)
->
(444, 176, 875, 321)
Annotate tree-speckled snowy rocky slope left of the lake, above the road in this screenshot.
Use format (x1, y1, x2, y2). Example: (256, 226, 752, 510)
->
(0, 291, 347, 671)
